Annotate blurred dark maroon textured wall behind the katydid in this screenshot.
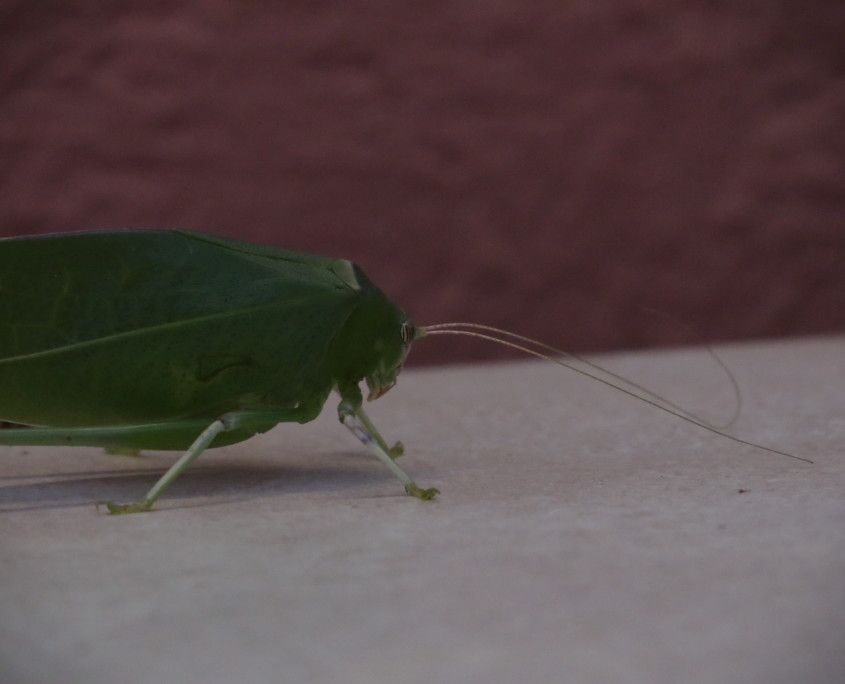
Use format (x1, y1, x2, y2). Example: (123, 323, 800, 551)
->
(0, 0, 845, 362)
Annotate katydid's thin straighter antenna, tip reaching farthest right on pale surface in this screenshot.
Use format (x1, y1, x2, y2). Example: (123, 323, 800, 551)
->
(417, 323, 813, 463)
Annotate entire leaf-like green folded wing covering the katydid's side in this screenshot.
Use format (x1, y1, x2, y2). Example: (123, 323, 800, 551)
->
(0, 230, 358, 427)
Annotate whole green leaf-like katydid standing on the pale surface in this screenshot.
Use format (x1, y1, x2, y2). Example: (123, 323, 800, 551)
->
(0, 230, 805, 513)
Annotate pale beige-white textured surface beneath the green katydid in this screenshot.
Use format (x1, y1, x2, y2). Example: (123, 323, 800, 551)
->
(0, 338, 845, 684)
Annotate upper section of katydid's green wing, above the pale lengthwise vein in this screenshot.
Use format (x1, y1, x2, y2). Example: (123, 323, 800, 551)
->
(0, 230, 356, 359)
